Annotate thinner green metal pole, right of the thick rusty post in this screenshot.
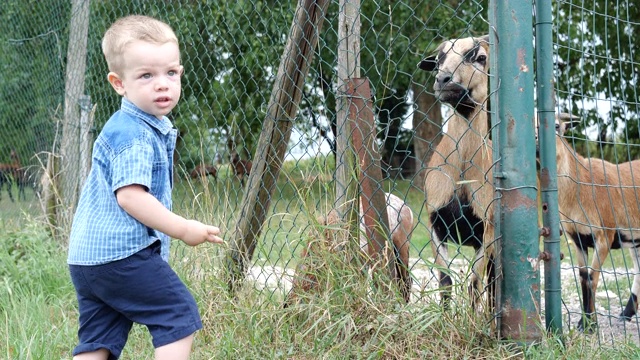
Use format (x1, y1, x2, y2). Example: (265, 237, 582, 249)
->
(535, 0, 562, 333)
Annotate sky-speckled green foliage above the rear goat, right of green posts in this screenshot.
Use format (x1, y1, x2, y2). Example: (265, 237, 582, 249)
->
(554, 0, 640, 162)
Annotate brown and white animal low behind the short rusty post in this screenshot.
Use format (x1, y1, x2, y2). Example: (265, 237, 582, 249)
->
(284, 193, 413, 307)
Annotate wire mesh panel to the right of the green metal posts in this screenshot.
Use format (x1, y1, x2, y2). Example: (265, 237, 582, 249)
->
(553, 1, 640, 342)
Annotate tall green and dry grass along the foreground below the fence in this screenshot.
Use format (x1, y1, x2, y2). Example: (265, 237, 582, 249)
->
(0, 222, 639, 359)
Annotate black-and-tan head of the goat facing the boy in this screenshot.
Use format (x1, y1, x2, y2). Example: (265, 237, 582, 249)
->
(418, 35, 489, 112)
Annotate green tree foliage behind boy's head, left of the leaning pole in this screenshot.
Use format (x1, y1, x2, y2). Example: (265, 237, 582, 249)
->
(89, 0, 291, 172)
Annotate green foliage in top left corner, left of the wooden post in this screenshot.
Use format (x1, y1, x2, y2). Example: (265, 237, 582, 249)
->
(0, 0, 71, 165)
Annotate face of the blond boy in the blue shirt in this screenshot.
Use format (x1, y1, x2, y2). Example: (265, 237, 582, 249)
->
(108, 41, 184, 119)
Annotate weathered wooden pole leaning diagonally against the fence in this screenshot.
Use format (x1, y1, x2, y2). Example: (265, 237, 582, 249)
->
(226, 0, 329, 292)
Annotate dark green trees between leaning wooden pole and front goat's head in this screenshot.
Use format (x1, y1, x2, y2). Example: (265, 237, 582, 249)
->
(303, 0, 489, 179)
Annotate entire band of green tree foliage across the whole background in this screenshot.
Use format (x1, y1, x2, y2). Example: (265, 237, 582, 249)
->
(0, 0, 640, 172)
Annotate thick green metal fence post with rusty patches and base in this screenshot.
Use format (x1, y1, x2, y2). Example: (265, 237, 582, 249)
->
(490, 0, 542, 343)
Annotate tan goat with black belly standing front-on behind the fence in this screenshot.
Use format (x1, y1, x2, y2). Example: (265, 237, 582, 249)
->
(418, 35, 495, 308)
